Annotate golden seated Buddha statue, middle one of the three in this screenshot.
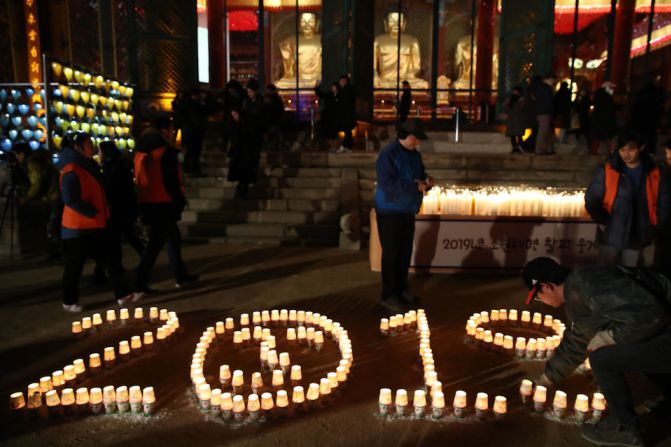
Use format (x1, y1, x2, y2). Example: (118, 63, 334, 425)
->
(373, 11, 429, 88)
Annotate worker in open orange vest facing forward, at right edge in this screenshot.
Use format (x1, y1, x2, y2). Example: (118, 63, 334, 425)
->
(585, 133, 671, 267)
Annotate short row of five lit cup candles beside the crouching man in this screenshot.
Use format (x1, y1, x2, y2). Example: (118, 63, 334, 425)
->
(520, 379, 606, 423)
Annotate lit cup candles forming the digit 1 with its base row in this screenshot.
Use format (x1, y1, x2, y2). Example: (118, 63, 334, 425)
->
(379, 309, 507, 420)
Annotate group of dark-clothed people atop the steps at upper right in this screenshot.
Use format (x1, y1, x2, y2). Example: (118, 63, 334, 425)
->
(504, 73, 665, 155)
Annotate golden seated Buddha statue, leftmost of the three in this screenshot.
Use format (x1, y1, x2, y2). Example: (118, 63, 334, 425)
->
(275, 12, 322, 88)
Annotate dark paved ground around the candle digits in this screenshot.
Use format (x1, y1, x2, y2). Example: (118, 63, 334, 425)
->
(0, 245, 671, 447)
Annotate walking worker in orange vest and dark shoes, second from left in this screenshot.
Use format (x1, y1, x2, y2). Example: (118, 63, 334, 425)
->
(134, 116, 198, 296)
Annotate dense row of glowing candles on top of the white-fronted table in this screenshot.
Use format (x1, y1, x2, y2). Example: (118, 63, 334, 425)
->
(420, 186, 587, 217)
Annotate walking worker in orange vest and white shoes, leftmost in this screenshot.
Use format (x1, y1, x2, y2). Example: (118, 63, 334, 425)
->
(59, 132, 138, 312)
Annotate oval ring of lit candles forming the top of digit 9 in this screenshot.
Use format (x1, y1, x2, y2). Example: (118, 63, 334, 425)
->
(466, 309, 566, 359)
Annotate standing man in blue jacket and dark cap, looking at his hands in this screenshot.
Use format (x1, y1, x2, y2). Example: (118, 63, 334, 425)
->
(375, 119, 434, 312)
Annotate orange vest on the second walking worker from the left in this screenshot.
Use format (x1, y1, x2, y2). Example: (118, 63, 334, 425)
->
(134, 147, 184, 203)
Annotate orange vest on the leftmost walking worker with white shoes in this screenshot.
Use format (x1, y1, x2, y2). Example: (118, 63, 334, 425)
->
(60, 163, 110, 230)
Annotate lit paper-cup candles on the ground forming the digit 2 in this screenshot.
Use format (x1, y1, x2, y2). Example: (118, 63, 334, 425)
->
(10, 307, 179, 415)
